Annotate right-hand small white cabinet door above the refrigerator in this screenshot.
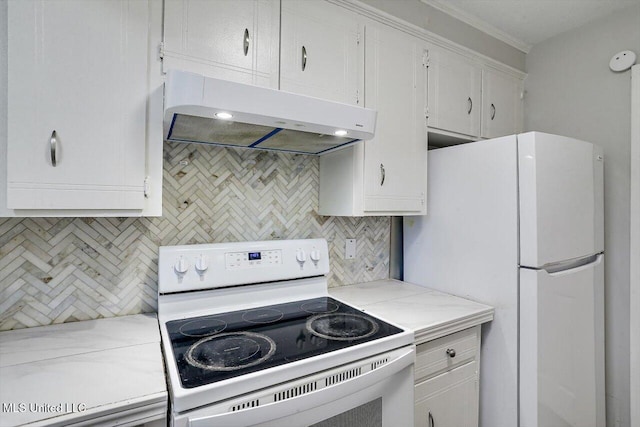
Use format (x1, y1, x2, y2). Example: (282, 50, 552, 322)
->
(482, 69, 522, 138)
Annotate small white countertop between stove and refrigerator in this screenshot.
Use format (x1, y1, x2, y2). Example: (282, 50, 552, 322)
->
(329, 279, 493, 344)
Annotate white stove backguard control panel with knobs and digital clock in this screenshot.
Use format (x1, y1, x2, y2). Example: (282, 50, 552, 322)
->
(158, 239, 329, 294)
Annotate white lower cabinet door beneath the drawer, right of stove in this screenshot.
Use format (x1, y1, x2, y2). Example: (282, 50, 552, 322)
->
(414, 362, 478, 427)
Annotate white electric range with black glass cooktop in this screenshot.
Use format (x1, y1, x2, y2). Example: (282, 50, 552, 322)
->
(158, 239, 415, 427)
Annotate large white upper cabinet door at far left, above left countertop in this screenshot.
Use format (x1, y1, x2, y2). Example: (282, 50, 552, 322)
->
(7, 0, 149, 209)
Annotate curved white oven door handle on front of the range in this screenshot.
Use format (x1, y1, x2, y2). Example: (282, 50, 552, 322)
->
(189, 346, 415, 427)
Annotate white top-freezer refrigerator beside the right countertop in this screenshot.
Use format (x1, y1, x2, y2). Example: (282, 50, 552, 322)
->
(404, 132, 605, 427)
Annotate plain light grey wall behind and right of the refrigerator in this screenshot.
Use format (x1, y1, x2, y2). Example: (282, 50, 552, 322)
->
(525, 4, 640, 427)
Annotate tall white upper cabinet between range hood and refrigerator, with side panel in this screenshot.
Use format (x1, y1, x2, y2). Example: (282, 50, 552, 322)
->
(319, 21, 427, 216)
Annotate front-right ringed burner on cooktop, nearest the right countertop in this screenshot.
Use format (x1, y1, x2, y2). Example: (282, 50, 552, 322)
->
(306, 313, 379, 341)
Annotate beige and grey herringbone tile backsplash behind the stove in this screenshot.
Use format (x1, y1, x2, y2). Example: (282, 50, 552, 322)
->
(0, 143, 390, 330)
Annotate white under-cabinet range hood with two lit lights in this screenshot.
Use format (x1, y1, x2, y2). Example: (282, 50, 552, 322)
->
(164, 70, 377, 154)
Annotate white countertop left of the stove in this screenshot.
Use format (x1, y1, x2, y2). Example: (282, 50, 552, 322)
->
(0, 314, 167, 427)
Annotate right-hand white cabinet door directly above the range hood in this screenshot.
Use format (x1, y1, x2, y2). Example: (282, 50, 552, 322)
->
(280, 0, 364, 105)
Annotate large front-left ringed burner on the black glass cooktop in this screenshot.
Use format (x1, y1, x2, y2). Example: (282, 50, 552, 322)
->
(185, 332, 276, 371)
